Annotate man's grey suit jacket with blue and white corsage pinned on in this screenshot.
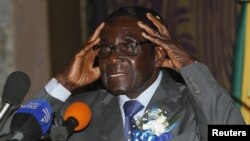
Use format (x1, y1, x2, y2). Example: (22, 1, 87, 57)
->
(58, 63, 244, 141)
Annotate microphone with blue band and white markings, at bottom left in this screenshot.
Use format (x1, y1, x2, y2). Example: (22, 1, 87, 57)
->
(10, 100, 52, 141)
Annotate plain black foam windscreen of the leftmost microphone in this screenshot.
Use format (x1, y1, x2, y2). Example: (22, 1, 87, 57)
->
(2, 71, 30, 106)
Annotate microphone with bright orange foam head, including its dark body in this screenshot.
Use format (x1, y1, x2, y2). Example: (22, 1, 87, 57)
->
(50, 101, 91, 141)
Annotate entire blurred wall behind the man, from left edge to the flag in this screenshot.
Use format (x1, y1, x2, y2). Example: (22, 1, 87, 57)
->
(0, 0, 246, 109)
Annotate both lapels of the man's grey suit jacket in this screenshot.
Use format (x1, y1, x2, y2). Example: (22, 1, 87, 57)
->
(96, 72, 186, 141)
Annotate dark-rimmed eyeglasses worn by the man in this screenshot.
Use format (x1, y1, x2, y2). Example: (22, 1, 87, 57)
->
(93, 41, 151, 58)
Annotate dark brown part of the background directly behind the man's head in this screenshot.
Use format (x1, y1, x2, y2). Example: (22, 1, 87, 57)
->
(48, 0, 240, 90)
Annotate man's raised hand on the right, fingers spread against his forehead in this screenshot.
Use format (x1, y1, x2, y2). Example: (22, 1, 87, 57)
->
(138, 13, 195, 71)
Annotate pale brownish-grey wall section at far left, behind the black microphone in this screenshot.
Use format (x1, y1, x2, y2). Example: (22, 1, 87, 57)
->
(0, 0, 51, 101)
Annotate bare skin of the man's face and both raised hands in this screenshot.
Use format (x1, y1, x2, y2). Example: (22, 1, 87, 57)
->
(56, 13, 195, 98)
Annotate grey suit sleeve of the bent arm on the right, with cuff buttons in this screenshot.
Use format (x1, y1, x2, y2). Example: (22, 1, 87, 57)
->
(180, 63, 245, 124)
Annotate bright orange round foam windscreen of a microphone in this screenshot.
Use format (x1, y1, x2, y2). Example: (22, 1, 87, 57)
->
(63, 101, 91, 131)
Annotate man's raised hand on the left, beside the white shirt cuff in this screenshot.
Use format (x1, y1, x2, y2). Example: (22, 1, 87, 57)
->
(55, 23, 105, 91)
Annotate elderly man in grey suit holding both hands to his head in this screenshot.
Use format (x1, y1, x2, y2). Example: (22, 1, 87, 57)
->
(47, 7, 244, 141)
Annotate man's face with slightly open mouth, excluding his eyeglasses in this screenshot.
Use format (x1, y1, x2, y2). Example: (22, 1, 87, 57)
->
(99, 17, 156, 98)
